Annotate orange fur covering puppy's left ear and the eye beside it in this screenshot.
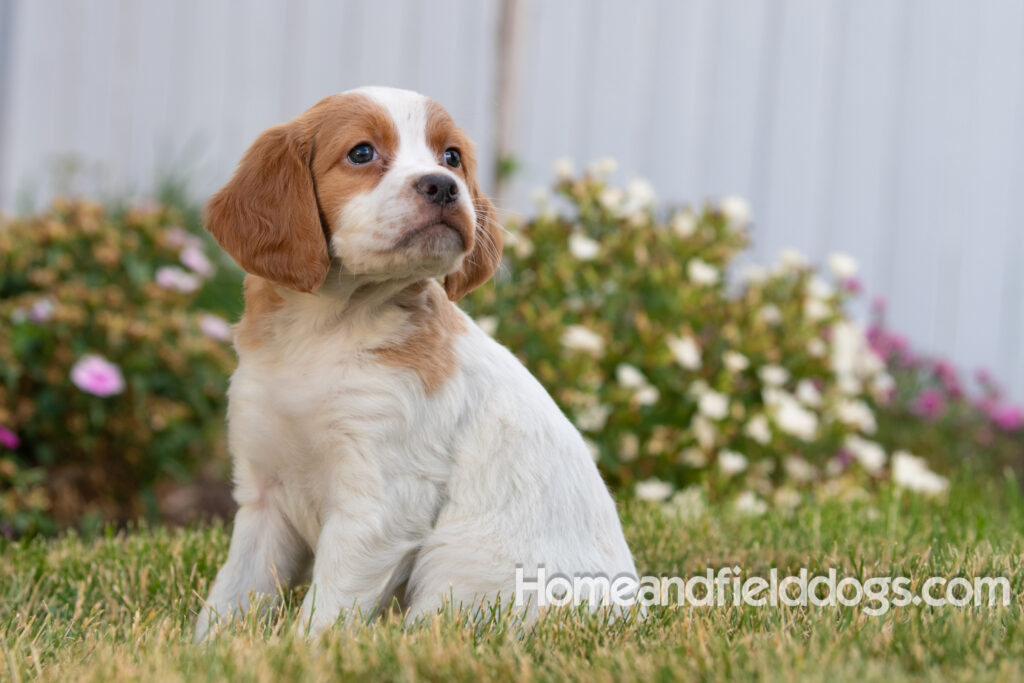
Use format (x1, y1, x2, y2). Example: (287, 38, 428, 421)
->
(206, 93, 398, 292)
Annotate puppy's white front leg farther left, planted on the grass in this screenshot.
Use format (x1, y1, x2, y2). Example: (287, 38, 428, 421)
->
(195, 501, 309, 643)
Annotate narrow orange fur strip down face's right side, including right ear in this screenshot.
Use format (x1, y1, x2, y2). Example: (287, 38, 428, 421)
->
(426, 99, 503, 301)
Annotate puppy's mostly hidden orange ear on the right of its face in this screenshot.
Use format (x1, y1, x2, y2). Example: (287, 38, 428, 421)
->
(444, 151, 504, 301)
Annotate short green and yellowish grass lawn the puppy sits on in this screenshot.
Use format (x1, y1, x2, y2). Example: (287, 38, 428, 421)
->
(0, 473, 1024, 682)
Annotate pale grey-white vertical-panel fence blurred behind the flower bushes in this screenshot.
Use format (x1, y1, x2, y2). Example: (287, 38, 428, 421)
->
(0, 0, 1024, 396)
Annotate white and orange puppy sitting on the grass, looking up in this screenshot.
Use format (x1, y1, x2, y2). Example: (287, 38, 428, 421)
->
(196, 88, 636, 640)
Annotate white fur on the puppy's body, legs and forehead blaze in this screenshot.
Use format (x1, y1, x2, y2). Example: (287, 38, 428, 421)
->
(196, 89, 636, 640)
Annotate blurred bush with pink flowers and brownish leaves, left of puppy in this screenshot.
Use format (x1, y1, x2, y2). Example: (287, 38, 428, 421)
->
(0, 203, 237, 535)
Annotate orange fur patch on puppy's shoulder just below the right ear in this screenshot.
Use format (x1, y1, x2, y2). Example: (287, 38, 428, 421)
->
(376, 282, 466, 394)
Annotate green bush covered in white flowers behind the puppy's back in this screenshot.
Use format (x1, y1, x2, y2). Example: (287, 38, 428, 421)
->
(467, 162, 947, 511)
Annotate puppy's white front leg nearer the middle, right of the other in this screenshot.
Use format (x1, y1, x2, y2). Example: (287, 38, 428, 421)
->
(302, 506, 415, 637)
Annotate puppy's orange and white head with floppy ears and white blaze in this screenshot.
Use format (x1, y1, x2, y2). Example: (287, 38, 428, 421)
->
(206, 88, 502, 300)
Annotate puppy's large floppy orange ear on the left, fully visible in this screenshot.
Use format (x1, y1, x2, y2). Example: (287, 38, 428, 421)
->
(206, 123, 331, 292)
